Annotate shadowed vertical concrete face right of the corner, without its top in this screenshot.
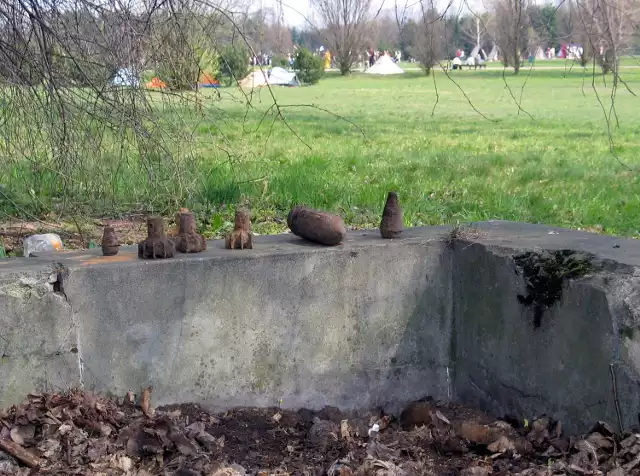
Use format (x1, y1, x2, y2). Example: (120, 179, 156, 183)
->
(455, 244, 624, 427)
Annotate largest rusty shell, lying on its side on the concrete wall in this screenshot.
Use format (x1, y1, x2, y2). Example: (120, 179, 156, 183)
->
(287, 206, 347, 246)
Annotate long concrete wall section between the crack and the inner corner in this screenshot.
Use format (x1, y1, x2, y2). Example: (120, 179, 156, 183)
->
(56, 232, 452, 414)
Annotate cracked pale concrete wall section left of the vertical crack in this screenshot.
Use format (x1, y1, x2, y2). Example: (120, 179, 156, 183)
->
(0, 259, 81, 403)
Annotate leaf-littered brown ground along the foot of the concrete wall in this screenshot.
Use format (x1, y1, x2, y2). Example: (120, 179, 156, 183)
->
(0, 388, 640, 476)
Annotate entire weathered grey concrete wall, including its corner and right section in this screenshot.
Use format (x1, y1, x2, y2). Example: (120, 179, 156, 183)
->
(0, 222, 640, 431)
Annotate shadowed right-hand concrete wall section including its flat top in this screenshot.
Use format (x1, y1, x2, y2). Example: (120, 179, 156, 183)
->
(452, 222, 640, 432)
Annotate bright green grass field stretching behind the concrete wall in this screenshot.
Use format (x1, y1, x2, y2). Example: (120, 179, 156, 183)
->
(3, 68, 640, 236)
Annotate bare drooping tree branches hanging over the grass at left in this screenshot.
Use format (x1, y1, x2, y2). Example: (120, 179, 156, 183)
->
(0, 0, 288, 215)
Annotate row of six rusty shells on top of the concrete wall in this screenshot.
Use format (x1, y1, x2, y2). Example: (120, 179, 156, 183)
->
(102, 192, 404, 259)
